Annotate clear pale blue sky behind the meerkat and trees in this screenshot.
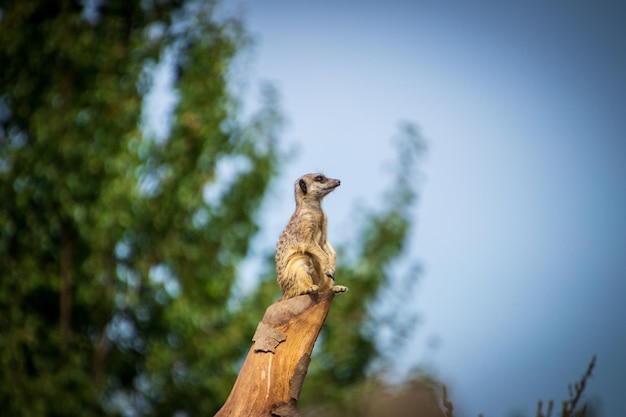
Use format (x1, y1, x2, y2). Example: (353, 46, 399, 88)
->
(204, 0, 626, 417)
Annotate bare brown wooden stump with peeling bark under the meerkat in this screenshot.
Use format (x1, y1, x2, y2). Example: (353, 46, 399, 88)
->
(215, 292, 335, 417)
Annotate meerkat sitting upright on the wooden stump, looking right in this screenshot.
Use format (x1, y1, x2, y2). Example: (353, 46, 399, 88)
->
(276, 174, 348, 300)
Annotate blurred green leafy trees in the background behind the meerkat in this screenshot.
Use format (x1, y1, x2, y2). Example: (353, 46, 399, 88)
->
(0, 0, 422, 417)
